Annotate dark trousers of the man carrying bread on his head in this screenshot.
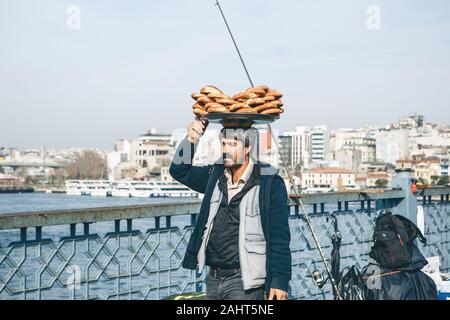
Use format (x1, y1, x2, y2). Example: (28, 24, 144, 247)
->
(205, 272, 265, 300)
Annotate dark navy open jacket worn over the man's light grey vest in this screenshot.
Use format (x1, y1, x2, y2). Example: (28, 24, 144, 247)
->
(169, 139, 292, 291)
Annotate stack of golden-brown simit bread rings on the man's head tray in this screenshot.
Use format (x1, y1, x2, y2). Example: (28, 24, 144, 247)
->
(191, 85, 284, 117)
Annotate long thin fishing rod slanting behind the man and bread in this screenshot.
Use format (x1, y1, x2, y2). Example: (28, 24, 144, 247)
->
(215, 0, 342, 300)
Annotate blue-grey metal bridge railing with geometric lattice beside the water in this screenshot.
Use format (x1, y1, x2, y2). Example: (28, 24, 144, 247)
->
(0, 188, 450, 299)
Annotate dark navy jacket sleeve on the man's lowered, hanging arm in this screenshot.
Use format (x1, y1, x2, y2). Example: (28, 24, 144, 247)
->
(269, 176, 292, 291)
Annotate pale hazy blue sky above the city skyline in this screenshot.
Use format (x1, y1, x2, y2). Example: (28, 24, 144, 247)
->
(0, 0, 450, 148)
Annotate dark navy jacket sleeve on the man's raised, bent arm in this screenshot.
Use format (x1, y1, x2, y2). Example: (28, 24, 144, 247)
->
(169, 138, 212, 193)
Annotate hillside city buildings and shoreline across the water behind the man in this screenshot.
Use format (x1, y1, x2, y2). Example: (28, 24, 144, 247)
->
(0, 114, 450, 192)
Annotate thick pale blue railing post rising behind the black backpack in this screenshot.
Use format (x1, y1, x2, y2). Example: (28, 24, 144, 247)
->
(391, 170, 417, 224)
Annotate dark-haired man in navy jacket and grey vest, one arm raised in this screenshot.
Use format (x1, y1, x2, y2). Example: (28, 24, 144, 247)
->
(170, 118, 291, 300)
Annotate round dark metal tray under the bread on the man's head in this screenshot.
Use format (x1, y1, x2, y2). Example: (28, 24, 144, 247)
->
(206, 112, 280, 128)
